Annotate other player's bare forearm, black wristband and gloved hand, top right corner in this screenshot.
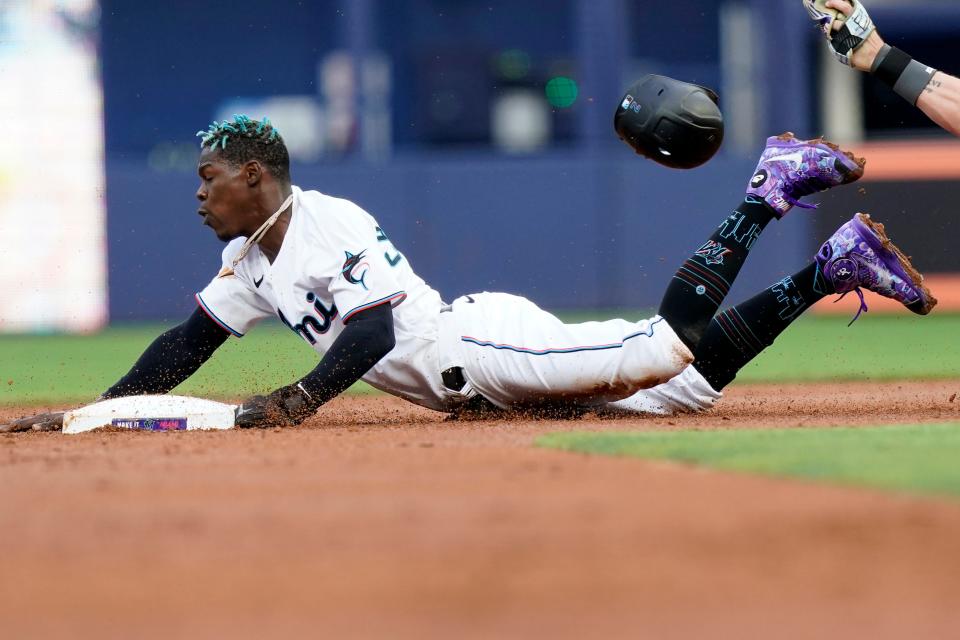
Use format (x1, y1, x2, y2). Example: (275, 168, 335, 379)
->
(803, 0, 960, 136)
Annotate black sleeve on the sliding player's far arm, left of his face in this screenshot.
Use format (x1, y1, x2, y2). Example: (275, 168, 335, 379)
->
(100, 307, 230, 399)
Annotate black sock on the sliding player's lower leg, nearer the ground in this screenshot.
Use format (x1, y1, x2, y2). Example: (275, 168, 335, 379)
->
(693, 262, 833, 391)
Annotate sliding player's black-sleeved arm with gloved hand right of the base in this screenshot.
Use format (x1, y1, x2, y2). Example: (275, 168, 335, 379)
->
(236, 302, 396, 427)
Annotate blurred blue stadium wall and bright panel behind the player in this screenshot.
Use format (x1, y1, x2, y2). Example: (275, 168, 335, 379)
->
(0, 0, 960, 332)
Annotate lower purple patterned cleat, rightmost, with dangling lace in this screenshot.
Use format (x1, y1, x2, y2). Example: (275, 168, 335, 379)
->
(816, 213, 937, 324)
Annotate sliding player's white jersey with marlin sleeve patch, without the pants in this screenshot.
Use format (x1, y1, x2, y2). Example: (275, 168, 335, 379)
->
(196, 187, 456, 410)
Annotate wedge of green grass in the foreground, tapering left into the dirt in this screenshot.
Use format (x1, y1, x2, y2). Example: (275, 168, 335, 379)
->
(537, 422, 960, 496)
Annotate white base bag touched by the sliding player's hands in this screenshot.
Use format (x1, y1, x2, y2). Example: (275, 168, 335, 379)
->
(63, 396, 237, 433)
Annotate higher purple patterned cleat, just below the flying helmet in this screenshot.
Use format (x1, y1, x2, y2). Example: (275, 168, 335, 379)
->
(747, 131, 866, 218)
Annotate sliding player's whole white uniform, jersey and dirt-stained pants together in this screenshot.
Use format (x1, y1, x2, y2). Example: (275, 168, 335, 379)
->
(196, 187, 719, 413)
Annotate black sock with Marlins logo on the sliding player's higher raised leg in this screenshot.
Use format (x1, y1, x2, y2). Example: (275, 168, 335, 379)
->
(660, 197, 773, 352)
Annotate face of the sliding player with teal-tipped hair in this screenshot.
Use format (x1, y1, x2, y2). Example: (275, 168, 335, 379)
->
(197, 149, 260, 242)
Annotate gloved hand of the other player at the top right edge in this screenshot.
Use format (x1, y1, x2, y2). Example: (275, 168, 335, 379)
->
(803, 0, 883, 71)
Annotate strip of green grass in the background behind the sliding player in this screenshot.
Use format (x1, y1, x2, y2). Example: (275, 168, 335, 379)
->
(0, 312, 960, 405)
